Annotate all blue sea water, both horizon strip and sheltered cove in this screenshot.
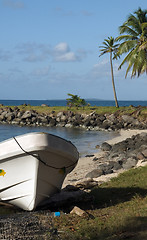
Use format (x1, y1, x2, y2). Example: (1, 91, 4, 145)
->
(0, 100, 147, 156)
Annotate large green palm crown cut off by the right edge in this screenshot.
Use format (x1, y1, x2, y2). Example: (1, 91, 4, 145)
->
(116, 8, 147, 77)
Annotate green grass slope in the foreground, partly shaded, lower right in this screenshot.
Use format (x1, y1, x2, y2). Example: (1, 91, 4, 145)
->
(50, 167, 147, 240)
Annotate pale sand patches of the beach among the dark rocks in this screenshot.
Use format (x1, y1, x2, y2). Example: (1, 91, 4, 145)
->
(63, 129, 147, 188)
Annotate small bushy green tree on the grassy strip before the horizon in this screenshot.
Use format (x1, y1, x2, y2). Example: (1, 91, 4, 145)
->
(66, 93, 87, 109)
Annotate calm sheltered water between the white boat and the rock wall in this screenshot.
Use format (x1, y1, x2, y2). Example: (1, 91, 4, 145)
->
(0, 124, 118, 156)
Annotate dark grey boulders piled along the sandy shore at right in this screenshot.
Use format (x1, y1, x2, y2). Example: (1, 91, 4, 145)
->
(85, 132, 147, 178)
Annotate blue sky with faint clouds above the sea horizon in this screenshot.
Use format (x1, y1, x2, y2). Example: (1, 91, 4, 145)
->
(0, 0, 147, 100)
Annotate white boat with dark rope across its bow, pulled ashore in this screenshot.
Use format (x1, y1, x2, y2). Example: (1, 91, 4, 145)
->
(0, 132, 79, 211)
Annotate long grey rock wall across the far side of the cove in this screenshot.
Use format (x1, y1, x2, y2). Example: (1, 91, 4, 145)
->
(0, 107, 147, 130)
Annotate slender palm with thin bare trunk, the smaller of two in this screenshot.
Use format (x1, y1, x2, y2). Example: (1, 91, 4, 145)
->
(99, 37, 119, 107)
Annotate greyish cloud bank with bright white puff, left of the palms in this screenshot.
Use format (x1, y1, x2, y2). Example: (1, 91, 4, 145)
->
(16, 42, 90, 62)
